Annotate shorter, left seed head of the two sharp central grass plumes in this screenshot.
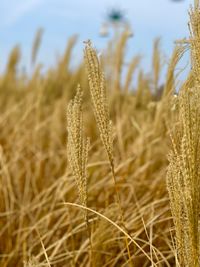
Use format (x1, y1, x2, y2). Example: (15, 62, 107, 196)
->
(67, 86, 89, 211)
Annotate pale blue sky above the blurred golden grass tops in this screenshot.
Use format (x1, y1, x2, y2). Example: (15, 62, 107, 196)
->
(0, 0, 192, 73)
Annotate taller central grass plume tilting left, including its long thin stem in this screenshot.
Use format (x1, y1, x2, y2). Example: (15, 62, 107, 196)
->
(84, 41, 132, 264)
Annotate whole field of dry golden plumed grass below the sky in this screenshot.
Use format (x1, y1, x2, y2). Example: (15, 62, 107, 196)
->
(0, 0, 200, 267)
